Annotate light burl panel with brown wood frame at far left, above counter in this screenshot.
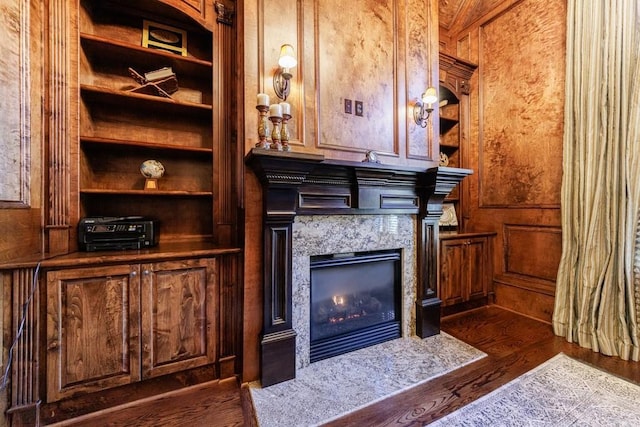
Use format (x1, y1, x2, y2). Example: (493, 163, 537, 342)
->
(0, 0, 44, 261)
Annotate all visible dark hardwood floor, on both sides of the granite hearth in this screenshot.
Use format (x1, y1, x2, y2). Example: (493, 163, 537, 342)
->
(50, 307, 640, 427)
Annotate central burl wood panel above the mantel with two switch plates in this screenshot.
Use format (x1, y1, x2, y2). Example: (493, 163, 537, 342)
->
(316, 0, 398, 155)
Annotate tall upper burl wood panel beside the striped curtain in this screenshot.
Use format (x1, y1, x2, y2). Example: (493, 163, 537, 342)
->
(479, 1, 564, 207)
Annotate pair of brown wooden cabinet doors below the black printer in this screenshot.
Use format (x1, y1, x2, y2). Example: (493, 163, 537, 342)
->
(46, 259, 218, 402)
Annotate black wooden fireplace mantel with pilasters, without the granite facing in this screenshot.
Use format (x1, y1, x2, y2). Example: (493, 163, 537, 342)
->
(246, 148, 472, 387)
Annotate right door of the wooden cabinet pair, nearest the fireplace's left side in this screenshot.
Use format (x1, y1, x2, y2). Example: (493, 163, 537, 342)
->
(141, 259, 218, 378)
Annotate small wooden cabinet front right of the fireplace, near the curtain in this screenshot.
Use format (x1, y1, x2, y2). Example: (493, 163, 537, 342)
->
(438, 233, 495, 314)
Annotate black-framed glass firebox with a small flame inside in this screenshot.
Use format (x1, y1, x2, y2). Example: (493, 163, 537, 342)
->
(310, 250, 401, 362)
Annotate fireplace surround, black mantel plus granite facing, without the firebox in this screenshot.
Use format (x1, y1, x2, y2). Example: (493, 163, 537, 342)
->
(246, 148, 472, 387)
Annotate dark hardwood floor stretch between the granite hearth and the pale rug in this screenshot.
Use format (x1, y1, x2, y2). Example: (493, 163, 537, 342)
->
(328, 307, 640, 426)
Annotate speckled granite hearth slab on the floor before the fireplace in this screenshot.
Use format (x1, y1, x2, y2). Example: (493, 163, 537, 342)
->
(249, 333, 486, 427)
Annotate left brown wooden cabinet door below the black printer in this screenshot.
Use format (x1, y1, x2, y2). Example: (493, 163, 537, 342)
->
(46, 265, 140, 401)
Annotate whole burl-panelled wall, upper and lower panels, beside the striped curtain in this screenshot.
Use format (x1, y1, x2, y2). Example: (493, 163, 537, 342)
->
(450, 0, 566, 321)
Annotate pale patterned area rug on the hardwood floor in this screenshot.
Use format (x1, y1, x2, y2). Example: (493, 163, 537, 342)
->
(429, 354, 640, 427)
